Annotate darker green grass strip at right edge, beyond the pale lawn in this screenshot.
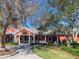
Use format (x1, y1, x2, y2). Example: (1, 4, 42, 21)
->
(61, 46, 79, 56)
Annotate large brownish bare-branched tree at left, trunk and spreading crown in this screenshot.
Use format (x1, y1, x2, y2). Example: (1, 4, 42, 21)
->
(0, 0, 36, 49)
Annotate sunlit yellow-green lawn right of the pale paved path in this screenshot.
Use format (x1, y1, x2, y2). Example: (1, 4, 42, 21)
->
(33, 48, 75, 59)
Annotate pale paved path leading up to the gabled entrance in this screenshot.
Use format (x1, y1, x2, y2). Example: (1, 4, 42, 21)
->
(1, 45, 42, 59)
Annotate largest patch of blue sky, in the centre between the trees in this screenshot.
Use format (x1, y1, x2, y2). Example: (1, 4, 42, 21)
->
(23, 0, 58, 28)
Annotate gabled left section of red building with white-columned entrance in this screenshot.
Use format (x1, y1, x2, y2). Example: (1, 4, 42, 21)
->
(5, 26, 35, 44)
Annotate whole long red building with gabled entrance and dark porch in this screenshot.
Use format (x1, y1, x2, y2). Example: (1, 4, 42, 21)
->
(5, 26, 79, 44)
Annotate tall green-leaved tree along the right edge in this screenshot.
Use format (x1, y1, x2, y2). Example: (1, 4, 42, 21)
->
(48, 0, 79, 46)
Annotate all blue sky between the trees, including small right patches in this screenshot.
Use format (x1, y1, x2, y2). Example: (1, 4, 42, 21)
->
(23, 0, 79, 28)
